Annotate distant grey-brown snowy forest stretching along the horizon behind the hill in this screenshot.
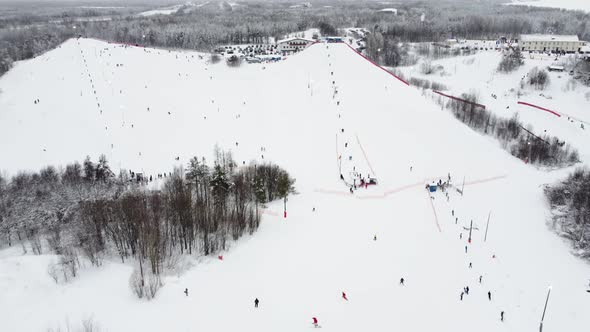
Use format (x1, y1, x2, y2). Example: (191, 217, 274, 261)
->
(0, 0, 590, 75)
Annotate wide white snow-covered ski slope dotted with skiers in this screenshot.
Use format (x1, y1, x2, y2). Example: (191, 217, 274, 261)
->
(0, 39, 590, 332)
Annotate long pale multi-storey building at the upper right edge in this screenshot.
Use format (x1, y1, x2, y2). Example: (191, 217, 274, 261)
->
(519, 35, 585, 53)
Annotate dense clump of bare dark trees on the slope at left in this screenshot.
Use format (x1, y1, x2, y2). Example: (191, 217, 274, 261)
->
(0, 149, 295, 298)
